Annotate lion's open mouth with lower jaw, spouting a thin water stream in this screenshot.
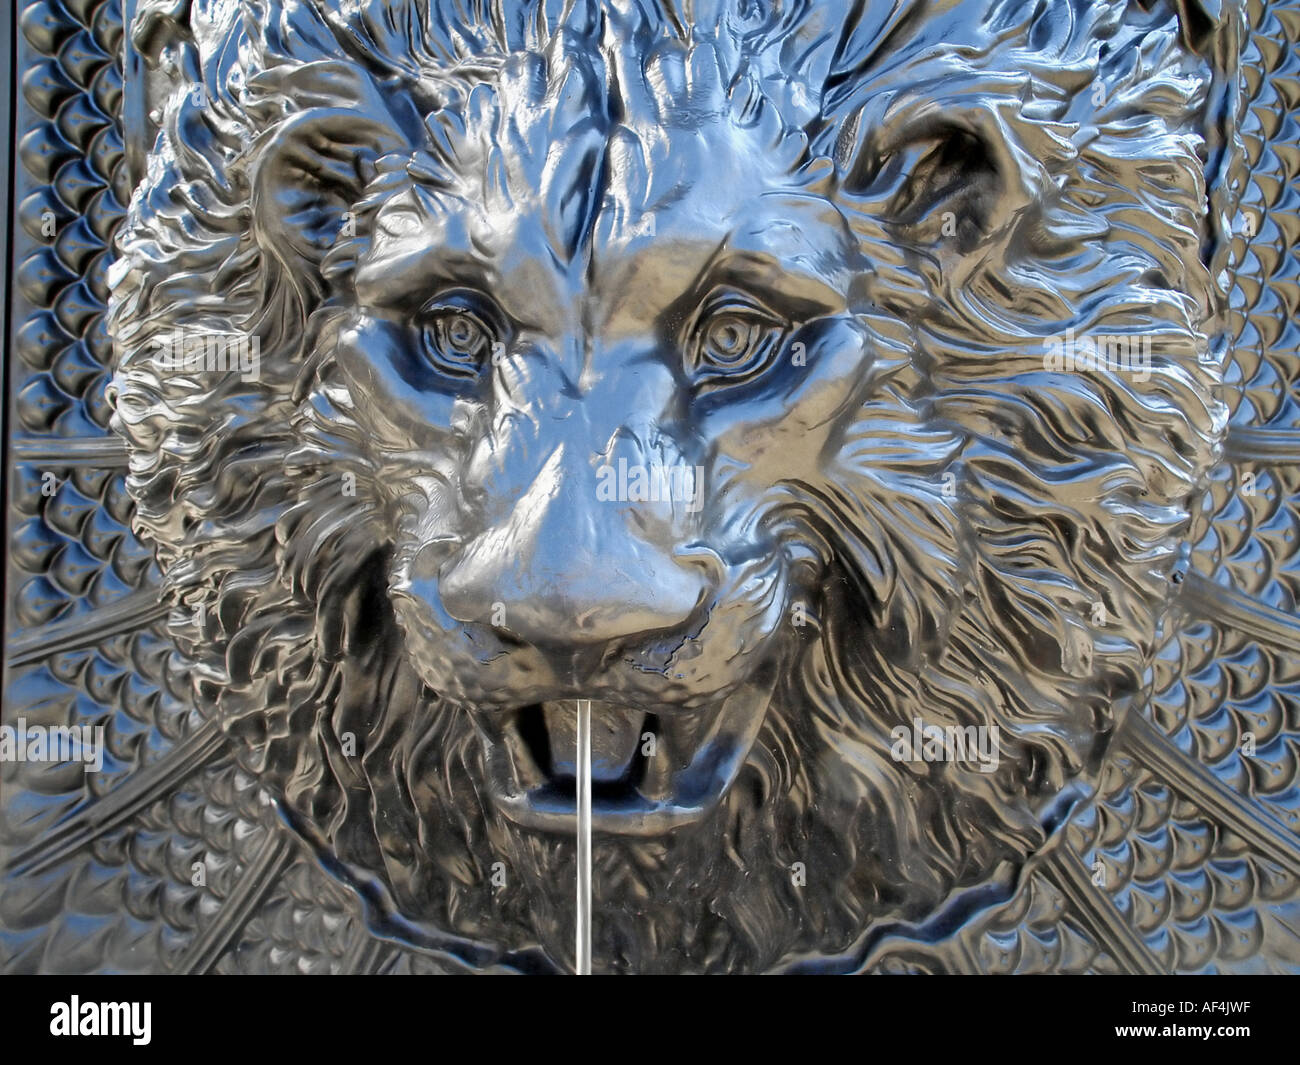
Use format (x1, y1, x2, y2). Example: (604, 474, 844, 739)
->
(475, 684, 771, 836)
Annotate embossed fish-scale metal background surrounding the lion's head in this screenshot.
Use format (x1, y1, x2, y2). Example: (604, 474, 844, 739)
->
(0, 0, 1300, 973)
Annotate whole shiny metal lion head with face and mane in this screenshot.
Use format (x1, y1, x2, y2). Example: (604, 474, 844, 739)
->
(113, 0, 1225, 970)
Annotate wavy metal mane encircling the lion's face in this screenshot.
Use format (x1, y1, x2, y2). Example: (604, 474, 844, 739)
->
(112, 0, 1230, 970)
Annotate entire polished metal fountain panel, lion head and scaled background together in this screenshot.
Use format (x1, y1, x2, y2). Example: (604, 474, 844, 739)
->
(0, 0, 1300, 973)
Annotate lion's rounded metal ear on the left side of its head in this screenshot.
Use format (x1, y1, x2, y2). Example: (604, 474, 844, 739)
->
(250, 61, 420, 278)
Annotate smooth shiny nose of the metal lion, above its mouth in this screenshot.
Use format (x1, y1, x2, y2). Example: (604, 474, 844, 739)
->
(438, 450, 710, 645)
